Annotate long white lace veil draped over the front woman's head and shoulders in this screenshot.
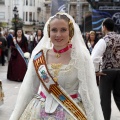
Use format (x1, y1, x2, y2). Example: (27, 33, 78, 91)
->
(10, 13, 104, 120)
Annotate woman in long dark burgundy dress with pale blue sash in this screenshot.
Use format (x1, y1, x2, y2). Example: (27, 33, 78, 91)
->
(7, 29, 28, 82)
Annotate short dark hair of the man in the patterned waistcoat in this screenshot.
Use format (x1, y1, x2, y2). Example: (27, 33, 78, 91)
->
(102, 18, 115, 31)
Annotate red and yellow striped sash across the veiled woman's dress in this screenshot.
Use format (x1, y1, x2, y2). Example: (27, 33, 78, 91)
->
(33, 50, 87, 120)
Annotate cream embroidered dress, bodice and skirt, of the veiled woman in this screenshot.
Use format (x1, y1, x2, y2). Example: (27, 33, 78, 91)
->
(19, 51, 84, 120)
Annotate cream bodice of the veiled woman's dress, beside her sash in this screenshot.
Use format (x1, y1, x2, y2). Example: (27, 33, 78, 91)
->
(39, 50, 79, 95)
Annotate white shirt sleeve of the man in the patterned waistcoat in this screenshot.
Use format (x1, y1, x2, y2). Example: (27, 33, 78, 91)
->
(91, 38, 106, 72)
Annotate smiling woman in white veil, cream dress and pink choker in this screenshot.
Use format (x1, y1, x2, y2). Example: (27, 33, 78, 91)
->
(10, 13, 104, 120)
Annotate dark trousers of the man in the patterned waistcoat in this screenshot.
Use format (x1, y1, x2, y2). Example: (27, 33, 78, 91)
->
(99, 69, 120, 120)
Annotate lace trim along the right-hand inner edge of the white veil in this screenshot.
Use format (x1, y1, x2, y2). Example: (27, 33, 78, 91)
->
(71, 48, 94, 120)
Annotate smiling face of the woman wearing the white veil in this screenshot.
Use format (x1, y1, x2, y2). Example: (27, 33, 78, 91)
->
(50, 18, 69, 47)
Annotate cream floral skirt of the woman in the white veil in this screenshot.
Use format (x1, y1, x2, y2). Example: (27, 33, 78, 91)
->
(19, 95, 85, 120)
